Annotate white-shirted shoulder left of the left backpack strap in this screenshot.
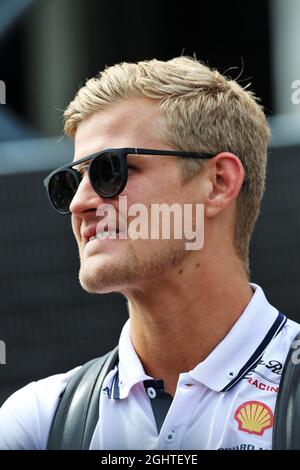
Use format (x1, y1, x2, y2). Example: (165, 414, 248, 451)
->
(0, 366, 80, 450)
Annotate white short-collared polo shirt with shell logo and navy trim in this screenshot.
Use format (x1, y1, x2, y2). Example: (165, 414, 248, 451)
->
(0, 284, 300, 450)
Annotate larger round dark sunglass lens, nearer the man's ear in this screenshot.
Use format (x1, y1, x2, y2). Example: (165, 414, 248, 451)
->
(90, 152, 123, 197)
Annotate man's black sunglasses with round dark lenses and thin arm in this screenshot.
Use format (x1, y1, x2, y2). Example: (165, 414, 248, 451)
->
(44, 148, 215, 214)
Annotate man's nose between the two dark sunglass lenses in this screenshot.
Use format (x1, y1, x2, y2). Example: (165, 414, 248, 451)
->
(70, 173, 103, 216)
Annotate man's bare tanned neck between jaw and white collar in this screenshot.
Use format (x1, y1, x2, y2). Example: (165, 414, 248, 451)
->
(126, 252, 253, 394)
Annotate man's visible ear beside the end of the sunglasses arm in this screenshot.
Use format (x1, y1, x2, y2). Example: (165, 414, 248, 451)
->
(205, 152, 245, 217)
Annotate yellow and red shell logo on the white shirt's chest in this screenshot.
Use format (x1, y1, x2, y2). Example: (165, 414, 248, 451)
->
(234, 401, 273, 436)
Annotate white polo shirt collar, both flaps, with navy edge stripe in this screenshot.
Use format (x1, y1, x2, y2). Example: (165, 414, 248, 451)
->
(114, 284, 286, 399)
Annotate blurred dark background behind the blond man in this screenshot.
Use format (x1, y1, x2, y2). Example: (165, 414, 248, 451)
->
(0, 0, 300, 403)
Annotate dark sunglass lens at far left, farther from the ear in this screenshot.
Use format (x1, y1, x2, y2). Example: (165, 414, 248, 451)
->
(49, 171, 78, 214)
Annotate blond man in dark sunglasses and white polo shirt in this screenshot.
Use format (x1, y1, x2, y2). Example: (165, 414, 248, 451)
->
(0, 57, 300, 450)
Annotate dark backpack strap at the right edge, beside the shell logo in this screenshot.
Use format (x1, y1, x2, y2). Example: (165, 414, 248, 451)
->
(272, 333, 300, 450)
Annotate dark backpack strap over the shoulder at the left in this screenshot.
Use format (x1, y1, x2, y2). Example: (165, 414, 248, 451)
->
(47, 347, 118, 450)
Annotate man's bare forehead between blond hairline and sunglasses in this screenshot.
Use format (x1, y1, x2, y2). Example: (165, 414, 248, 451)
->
(74, 98, 162, 160)
